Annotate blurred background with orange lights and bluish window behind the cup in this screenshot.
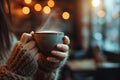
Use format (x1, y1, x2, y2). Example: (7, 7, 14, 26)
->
(6, 0, 120, 80)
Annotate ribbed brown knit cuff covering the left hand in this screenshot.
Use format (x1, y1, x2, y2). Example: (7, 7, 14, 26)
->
(7, 42, 38, 76)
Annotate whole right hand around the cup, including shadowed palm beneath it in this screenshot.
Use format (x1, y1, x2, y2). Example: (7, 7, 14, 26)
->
(38, 36, 70, 72)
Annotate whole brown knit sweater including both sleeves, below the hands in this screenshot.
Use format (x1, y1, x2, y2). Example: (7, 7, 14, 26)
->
(0, 34, 67, 80)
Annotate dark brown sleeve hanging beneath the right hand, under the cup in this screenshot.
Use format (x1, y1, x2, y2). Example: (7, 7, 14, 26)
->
(34, 54, 68, 80)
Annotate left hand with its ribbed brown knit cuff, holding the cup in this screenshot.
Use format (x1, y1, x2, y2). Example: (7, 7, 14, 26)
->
(7, 33, 38, 76)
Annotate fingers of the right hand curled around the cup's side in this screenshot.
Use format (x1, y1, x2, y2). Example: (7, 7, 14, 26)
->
(47, 36, 70, 63)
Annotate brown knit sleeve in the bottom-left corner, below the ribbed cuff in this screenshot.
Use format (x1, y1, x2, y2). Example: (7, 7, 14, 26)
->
(0, 66, 32, 80)
